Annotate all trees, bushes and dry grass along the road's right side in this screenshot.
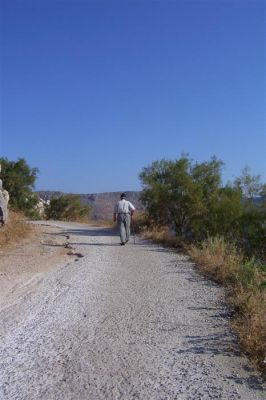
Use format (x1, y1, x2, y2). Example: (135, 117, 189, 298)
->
(138, 155, 266, 373)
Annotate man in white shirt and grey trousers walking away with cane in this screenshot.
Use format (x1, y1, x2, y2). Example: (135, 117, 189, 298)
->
(114, 193, 135, 246)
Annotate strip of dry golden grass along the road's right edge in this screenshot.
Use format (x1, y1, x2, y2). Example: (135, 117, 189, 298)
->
(188, 234, 266, 375)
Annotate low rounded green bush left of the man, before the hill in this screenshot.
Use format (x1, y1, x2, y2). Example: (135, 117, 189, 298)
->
(46, 194, 90, 221)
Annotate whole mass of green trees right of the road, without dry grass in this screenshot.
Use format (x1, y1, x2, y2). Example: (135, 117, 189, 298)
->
(140, 156, 266, 256)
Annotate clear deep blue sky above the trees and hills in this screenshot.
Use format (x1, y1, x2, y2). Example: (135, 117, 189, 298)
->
(0, 0, 266, 193)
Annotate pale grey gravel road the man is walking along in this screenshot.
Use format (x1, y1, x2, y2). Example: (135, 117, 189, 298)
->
(0, 223, 266, 400)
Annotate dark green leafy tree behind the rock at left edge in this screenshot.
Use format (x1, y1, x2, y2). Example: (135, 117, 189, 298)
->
(0, 158, 39, 216)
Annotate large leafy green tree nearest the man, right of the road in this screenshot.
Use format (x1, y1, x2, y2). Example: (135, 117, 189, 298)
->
(140, 156, 228, 238)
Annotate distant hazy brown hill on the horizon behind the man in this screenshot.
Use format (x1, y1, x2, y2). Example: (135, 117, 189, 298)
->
(36, 191, 143, 220)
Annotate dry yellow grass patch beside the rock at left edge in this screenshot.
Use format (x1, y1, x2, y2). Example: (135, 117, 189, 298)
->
(0, 211, 32, 248)
